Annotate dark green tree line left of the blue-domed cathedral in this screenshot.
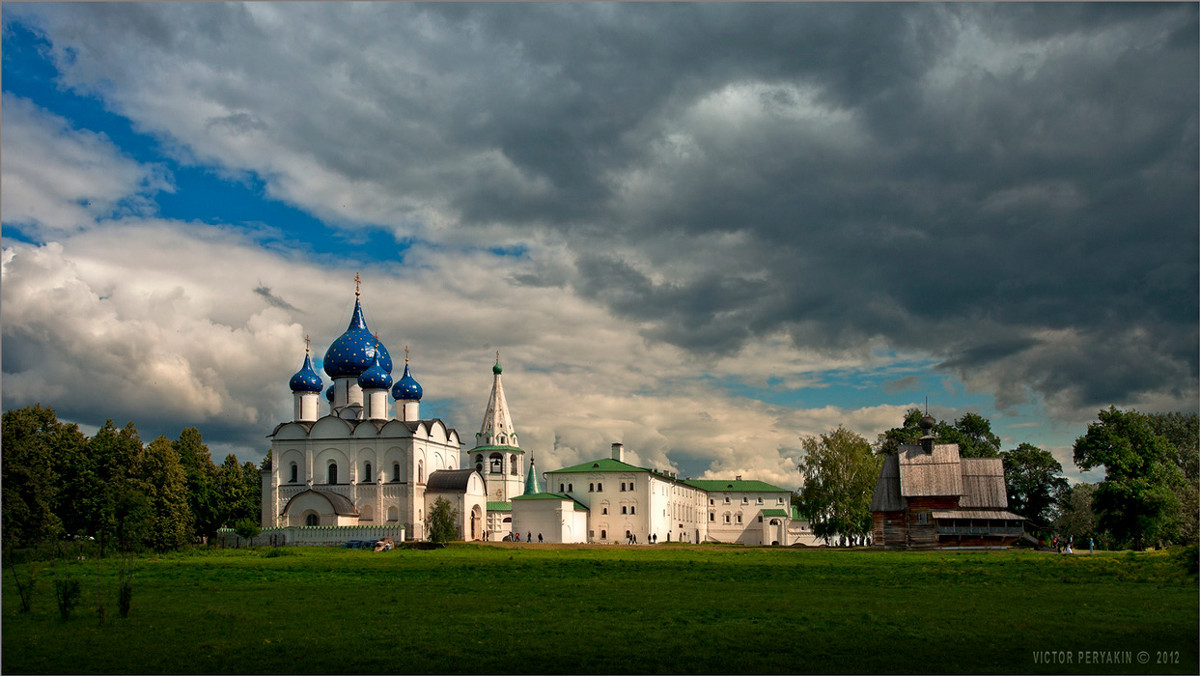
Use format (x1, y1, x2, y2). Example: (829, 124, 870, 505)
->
(0, 405, 262, 556)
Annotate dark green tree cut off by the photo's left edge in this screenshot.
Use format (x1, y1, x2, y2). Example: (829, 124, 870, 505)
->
(0, 406, 62, 549)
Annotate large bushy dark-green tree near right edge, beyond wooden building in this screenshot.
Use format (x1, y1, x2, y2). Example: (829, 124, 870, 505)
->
(1075, 407, 1186, 550)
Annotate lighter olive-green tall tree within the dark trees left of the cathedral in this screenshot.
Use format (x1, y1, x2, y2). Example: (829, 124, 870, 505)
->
(139, 436, 192, 551)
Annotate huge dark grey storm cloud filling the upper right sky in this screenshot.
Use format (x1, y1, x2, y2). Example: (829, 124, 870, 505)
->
(18, 4, 1200, 415)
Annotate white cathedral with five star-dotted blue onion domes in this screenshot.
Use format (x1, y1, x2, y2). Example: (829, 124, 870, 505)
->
(262, 277, 487, 539)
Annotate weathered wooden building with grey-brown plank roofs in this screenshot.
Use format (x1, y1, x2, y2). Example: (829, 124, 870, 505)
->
(871, 417, 1024, 549)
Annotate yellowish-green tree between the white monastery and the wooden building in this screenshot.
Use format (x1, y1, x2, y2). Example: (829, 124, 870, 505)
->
(798, 426, 883, 538)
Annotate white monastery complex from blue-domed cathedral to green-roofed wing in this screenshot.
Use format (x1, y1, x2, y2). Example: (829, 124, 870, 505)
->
(262, 276, 817, 545)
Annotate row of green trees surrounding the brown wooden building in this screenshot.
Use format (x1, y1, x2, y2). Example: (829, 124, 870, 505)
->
(793, 407, 1200, 550)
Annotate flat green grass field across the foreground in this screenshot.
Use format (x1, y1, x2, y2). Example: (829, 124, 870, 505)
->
(0, 545, 1200, 674)
